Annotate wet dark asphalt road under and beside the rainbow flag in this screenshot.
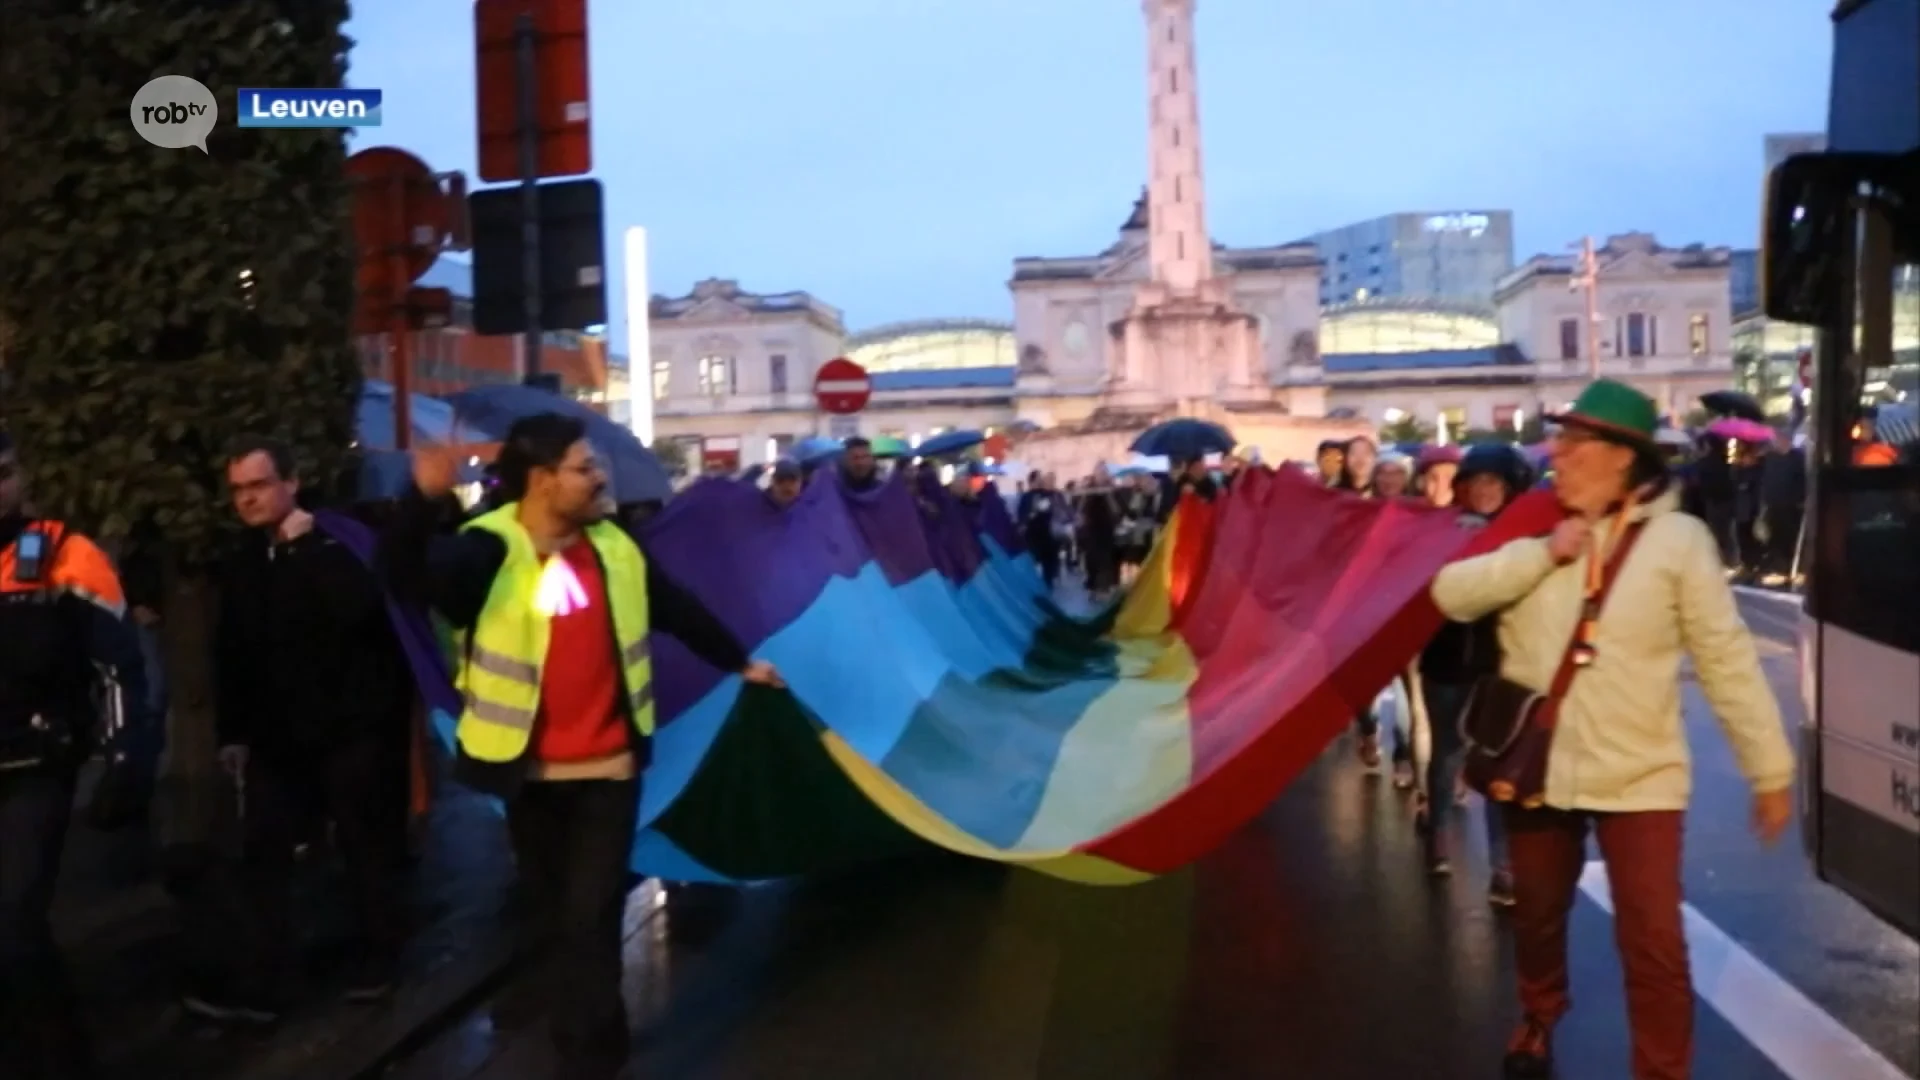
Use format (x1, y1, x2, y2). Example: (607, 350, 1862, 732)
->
(390, 598, 1920, 1080)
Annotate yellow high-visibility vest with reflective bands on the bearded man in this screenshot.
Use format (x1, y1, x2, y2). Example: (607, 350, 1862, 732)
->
(455, 503, 653, 763)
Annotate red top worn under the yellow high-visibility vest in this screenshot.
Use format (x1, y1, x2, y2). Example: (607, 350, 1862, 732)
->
(534, 540, 630, 761)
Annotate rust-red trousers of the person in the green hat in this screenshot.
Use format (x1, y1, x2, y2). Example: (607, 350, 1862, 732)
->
(1507, 809, 1693, 1080)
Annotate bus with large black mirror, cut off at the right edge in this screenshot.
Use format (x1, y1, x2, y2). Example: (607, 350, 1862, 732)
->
(1761, 0, 1920, 938)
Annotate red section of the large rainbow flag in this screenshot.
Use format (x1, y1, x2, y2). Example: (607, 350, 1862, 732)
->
(1087, 471, 1561, 872)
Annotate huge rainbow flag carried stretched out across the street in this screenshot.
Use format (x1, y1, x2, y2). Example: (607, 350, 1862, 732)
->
(634, 469, 1557, 884)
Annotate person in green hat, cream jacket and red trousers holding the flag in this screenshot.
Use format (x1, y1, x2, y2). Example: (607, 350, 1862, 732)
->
(1432, 379, 1793, 1080)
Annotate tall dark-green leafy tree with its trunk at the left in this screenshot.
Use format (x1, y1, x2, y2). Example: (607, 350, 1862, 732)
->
(0, 0, 359, 840)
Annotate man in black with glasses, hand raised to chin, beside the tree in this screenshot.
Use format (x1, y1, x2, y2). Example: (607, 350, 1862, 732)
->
(184, 440, 415, 1022)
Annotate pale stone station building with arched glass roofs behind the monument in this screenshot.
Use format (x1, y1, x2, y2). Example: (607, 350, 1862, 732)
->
(653, 219, 1751, 467)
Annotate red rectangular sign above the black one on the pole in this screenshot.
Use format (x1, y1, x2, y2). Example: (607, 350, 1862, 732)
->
(474, 0, 593, 184)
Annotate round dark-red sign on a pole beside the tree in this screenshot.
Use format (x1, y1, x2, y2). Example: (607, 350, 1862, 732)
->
(348, 146, 453, 305)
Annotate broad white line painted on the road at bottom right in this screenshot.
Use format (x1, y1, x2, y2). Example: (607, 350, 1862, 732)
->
(1580, 861, 1912, 1080)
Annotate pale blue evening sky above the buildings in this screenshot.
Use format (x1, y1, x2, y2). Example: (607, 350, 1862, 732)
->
(348, 0, 1832, 352)
